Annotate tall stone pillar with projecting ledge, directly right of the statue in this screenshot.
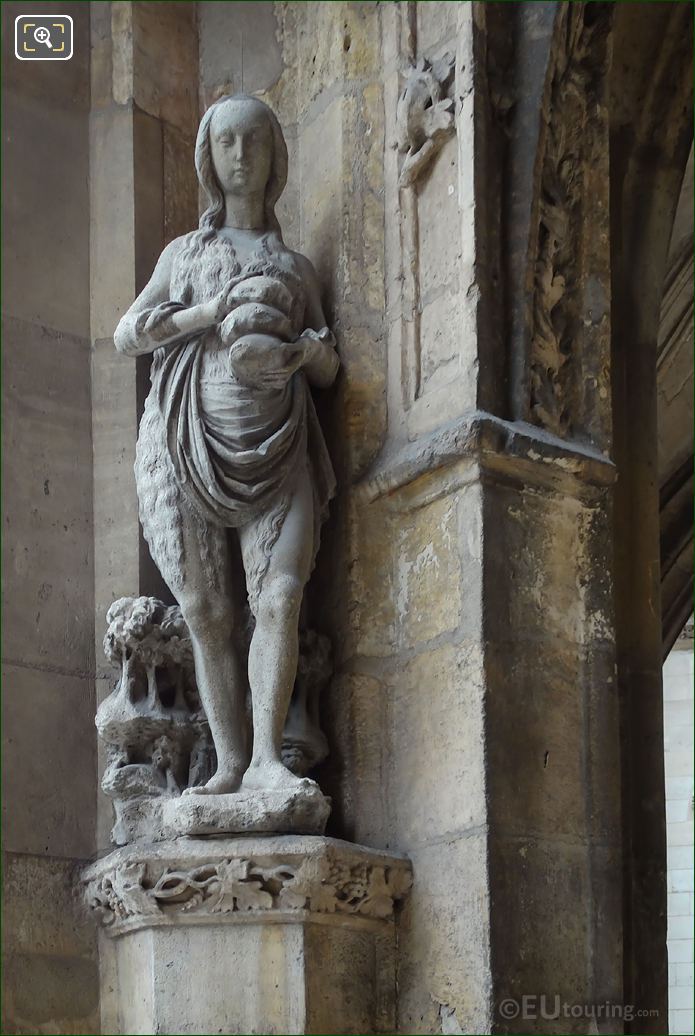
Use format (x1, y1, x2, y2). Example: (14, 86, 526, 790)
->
(319, 3, 622, 1033)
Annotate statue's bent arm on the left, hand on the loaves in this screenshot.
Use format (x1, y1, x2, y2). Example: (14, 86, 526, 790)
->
(114, 237, 223, 356)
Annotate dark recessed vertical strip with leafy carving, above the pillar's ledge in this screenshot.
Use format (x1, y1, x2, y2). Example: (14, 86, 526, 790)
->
(529, 3, 610, 444)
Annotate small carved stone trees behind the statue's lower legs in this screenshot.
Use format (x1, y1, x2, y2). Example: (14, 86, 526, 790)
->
(96, 597, 331, 844)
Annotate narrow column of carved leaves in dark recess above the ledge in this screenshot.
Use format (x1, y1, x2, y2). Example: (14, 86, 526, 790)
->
(530, 3, 610, 436)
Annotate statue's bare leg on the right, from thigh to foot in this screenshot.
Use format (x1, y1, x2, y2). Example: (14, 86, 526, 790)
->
(239, 466, 314, 790)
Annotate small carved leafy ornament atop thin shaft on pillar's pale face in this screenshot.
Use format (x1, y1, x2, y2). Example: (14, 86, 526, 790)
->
(396, 54, 455, 188)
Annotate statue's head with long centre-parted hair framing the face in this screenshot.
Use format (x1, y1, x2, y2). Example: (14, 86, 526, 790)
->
(196, 93, 287, 230)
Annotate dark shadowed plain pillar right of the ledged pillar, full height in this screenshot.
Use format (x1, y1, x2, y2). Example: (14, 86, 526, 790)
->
(610, 5, 693, 1033)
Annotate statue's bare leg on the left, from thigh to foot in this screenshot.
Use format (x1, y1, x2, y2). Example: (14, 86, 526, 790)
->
(161, 510, 249, 795)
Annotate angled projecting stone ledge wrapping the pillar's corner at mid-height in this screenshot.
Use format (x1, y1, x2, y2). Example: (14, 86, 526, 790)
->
(356, 410, 615, 502)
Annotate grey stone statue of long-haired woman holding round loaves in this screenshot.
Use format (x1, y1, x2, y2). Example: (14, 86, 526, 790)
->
(115, 95, 339, 808)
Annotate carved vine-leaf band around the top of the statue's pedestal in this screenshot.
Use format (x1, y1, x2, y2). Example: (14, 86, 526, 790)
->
(85, 855, 411, 926)
